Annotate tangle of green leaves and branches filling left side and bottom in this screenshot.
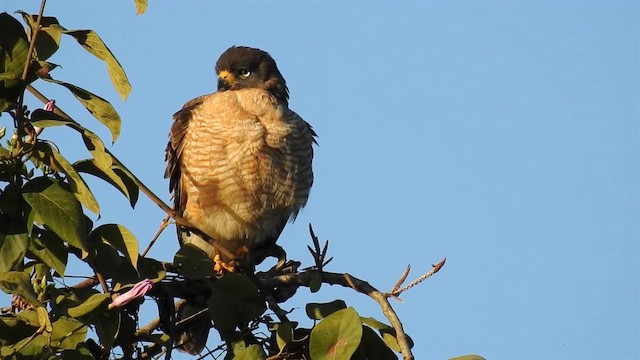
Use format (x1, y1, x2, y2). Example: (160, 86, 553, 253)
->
(0, 0, 460, 360)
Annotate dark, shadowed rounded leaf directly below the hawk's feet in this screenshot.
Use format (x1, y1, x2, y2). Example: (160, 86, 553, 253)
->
(209, 273, 267, 332)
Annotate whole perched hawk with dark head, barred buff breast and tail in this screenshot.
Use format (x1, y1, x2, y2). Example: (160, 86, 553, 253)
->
(165, 46, 316, 354)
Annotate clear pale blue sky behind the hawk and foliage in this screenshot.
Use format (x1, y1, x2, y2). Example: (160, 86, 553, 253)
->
(0, 0, 640, 359)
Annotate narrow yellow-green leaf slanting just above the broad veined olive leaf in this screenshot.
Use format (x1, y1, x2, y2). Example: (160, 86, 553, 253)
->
(31, 141, 100, 215)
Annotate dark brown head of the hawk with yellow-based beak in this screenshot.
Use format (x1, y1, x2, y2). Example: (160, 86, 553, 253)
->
(216, 46, 289, 104)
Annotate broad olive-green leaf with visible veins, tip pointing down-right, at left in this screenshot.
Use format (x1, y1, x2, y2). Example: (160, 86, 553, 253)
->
(22, 177, 88, 251)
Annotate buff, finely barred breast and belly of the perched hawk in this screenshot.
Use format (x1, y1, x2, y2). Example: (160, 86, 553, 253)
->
(180, 89, 314, 258)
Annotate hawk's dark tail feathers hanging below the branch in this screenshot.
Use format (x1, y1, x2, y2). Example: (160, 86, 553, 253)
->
(176, 303, 211, 355)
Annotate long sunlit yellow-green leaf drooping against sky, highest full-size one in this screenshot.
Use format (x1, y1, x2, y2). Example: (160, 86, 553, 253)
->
(63, 30, 131, 101)
